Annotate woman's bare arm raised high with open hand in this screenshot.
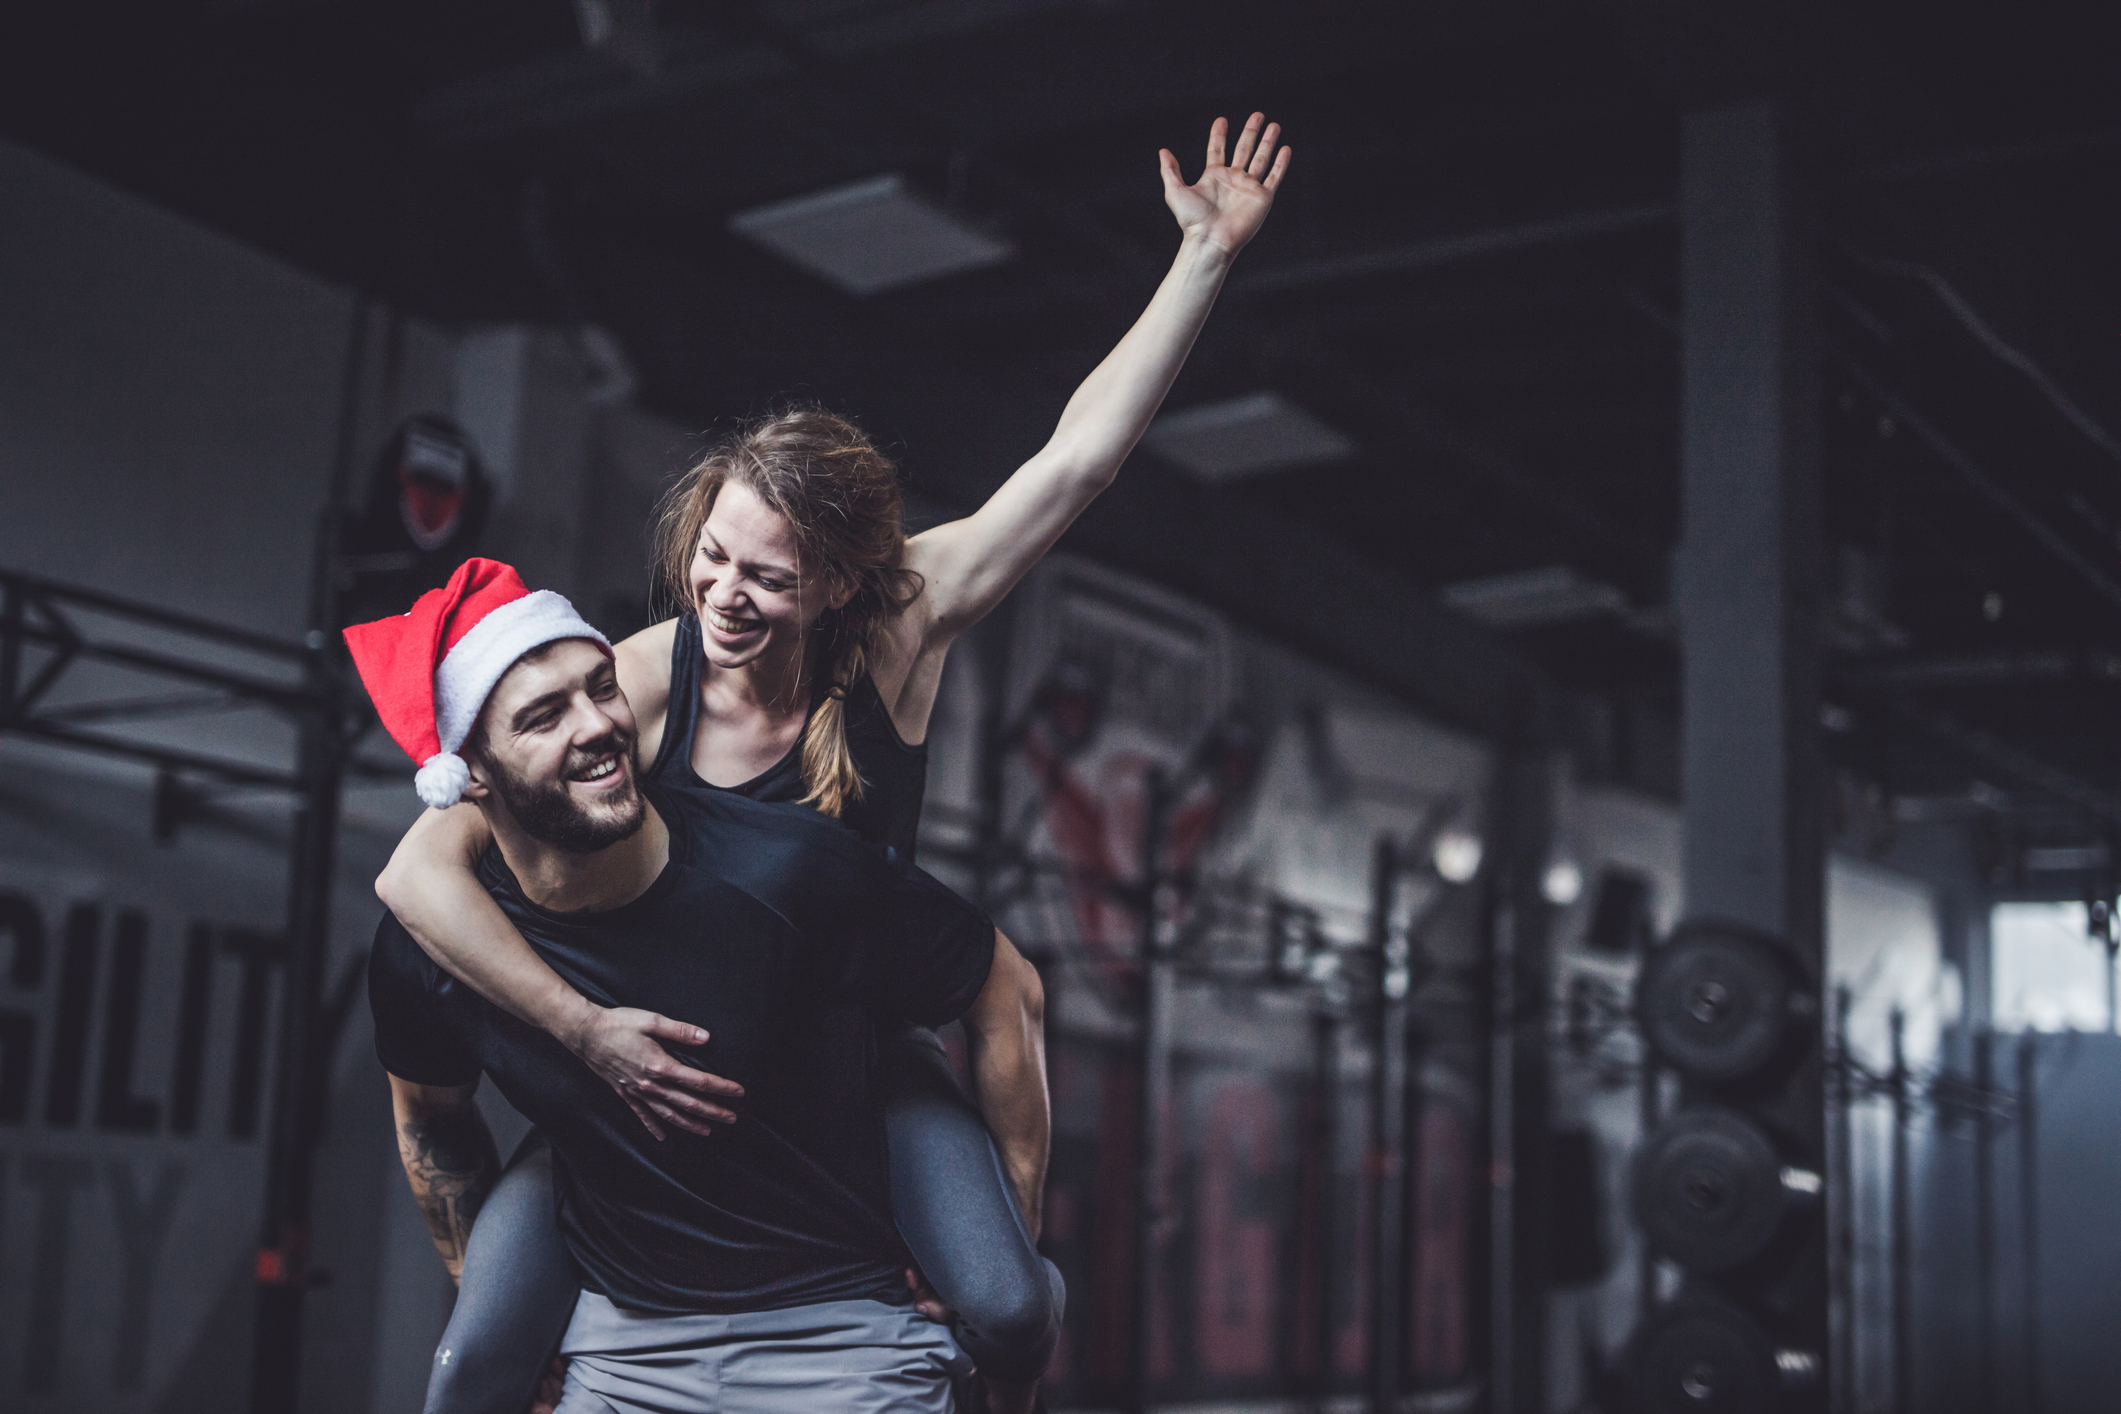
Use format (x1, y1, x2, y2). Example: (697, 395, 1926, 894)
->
(901, 112, 1290, 653)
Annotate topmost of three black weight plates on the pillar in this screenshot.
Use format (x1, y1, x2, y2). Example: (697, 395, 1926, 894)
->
(1635, 924, 1796, 1081)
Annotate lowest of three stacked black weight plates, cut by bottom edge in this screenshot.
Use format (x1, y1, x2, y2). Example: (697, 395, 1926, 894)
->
(1627, 1300, 1782, 1414)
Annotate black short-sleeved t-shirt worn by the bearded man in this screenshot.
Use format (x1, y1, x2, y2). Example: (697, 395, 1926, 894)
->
(369, 786, 995, 1312)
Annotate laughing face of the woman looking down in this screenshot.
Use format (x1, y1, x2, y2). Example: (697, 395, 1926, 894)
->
(691, 481, 848, 668)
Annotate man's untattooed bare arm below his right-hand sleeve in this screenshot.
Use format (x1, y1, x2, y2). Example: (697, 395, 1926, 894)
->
(965, 931, 1052, 1240)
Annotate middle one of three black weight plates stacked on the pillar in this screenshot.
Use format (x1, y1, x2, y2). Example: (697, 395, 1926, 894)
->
(1633, 1104, 1790, 1276)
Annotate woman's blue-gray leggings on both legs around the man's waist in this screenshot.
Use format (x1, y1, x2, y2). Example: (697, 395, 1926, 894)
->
(426, 1030, 1067, 1414)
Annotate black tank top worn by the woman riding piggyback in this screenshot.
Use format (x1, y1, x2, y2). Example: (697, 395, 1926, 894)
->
(647, 615, 927, 861)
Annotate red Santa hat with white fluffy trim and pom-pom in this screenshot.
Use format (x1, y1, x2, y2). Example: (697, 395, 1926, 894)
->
(346, 560, 611, 810)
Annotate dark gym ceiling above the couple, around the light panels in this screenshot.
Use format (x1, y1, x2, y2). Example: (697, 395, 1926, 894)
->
(0, 0, 2121, 864)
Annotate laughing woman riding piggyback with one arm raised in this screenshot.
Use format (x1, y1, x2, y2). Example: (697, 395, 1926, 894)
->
(378, 112, 1290, 1414)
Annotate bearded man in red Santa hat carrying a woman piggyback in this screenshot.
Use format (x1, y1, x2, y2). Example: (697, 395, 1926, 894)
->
(348, 562, 1046, 1414)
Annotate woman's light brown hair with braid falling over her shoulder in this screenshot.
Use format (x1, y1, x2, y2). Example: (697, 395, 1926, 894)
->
(655, 407, 921, 816)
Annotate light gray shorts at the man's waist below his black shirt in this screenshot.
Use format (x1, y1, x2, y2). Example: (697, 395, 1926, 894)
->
(556, 1291, 971, 1414)
